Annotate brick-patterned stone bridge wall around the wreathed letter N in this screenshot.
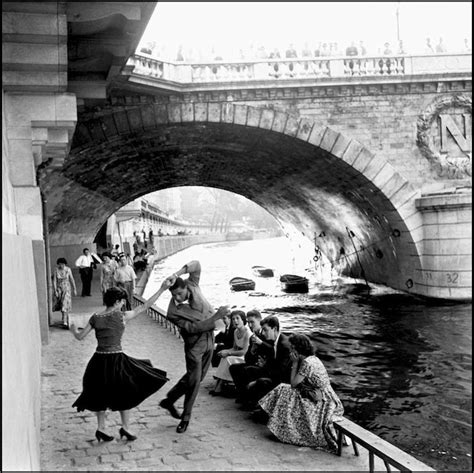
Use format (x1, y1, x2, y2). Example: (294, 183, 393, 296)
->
(228, 82, 471, 192)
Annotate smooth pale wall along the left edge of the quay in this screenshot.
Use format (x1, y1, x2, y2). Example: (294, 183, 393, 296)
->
(2, 96, 41, 470)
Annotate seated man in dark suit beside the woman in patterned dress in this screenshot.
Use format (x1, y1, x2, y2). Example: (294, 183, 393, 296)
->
(231, 315, 292, 408)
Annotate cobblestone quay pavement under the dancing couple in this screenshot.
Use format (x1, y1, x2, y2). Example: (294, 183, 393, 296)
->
(41, 280, 374, 471)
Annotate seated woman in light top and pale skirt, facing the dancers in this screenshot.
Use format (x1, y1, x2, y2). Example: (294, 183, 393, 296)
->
(210, 310, 252, 396)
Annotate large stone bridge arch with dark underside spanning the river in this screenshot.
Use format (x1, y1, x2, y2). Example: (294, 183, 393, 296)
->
(40, 102, 422, 292)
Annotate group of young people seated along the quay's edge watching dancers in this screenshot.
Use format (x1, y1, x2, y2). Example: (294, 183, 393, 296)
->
(210, 310, 344, 452)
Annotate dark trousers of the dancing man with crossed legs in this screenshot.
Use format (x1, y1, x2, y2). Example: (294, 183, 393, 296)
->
(166, 332, 214, 421)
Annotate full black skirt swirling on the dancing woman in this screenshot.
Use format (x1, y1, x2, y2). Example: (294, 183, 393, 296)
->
(72, 352, 168, 412)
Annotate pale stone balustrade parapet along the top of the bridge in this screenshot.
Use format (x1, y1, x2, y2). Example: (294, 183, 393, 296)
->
(122, 53, 472, 93)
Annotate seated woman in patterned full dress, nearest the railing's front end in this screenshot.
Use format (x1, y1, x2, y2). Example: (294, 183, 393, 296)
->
(259, 334, 344, 452)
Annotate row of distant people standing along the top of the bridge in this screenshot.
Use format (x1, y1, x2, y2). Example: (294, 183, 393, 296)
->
(139, 37, 471, 63)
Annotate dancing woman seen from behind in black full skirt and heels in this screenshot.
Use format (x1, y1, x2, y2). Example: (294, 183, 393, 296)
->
(70, 281, 169, 442)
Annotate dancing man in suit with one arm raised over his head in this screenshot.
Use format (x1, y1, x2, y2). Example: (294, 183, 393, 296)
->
(160, 261, 229, 434)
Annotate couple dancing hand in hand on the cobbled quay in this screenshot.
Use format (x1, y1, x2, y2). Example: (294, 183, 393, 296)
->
(70, 261, 229, 442)
